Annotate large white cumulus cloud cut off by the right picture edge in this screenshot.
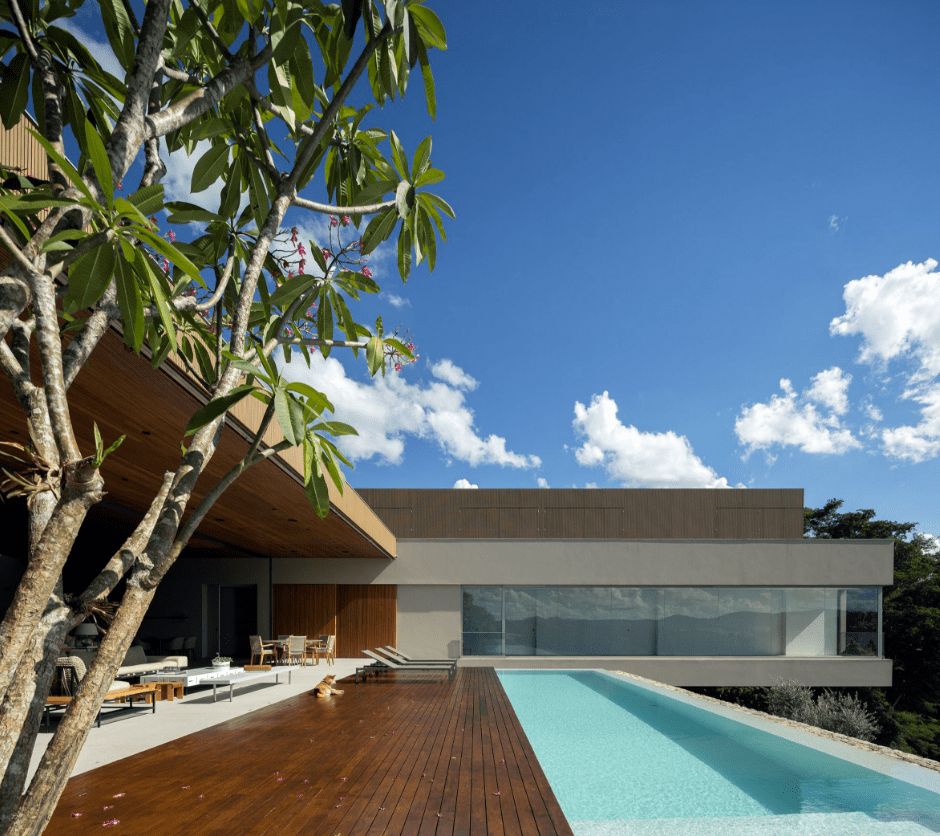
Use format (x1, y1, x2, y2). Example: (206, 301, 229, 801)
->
(829, 258, 940, 462)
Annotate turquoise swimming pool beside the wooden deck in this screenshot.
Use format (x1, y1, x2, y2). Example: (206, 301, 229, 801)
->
(498, 670, 940, 836)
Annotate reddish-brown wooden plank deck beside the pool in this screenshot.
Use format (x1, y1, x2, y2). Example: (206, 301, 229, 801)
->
(46, 668, 571, 836)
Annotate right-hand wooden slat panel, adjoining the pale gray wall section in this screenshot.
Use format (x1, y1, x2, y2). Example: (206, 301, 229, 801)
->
(336, 584, 398, 659)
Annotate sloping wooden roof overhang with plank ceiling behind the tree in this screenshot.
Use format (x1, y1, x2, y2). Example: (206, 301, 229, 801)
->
(0, 331, 396, 559)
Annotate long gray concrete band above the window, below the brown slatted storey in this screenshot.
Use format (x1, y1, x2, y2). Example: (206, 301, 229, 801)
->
(274, 540, 894, 586)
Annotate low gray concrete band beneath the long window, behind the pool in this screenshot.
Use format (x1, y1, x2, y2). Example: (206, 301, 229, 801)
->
(459, 656, 891, 688)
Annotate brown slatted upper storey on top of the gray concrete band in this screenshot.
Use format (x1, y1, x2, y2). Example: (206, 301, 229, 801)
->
(359, 488, 803, 540)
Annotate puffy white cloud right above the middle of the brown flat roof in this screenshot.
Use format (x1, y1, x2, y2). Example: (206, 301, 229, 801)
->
(572, 392, 728, 488)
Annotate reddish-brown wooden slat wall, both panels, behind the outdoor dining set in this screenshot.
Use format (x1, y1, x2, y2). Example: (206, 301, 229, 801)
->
(274, 583, 398, 659)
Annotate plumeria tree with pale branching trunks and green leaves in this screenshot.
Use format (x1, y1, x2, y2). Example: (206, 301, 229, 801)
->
(0, 0, 453, 834)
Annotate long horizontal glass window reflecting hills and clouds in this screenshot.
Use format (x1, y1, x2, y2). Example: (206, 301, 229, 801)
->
(463, 586, 881, 656)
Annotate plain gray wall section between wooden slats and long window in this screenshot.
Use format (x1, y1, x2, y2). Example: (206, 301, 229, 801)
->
(398, 586, 461, 659)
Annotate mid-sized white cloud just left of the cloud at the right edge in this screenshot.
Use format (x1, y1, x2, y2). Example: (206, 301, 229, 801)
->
(734, 366, 861, 459)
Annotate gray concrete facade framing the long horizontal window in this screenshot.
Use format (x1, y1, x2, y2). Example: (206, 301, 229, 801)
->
(272, 539, 894, 687)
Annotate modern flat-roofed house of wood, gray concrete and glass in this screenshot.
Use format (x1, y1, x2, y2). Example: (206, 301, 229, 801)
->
(0, 123, 893, 686)
